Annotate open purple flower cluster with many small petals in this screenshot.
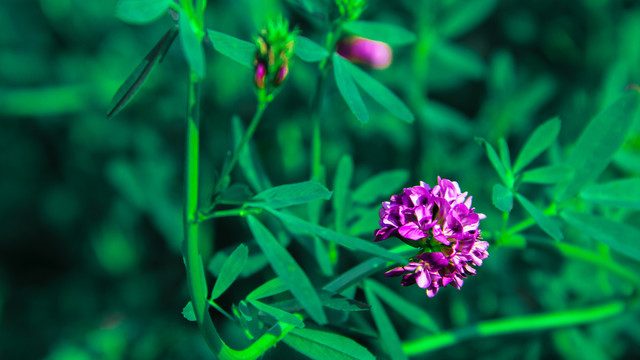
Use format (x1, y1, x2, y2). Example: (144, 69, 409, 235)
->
(375, 177, 489, 297)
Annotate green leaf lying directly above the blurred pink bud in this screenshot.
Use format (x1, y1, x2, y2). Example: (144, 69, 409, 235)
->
(344, 20, 416, 46)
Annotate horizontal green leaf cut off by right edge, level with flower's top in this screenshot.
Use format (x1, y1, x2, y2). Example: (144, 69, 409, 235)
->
(580, 178, 640, 210)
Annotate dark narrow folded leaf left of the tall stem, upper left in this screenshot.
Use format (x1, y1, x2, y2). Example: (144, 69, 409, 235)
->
(107, 28, 178, 119)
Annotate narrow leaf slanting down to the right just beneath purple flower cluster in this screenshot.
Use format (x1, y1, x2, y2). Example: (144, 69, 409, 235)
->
(367, 280, 440, 333)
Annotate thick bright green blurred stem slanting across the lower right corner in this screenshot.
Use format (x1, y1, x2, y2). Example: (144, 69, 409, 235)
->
(402, 300, 627, 356)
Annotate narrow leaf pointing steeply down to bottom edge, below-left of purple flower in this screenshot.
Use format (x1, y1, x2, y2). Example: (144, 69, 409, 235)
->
(364, 281, 408, 360)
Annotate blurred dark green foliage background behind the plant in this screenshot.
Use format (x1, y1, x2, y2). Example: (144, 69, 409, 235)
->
(0, 0, 640, 359)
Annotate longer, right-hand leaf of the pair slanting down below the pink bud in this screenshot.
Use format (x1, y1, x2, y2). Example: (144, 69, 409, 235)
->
(340, 58, 415, 123)
